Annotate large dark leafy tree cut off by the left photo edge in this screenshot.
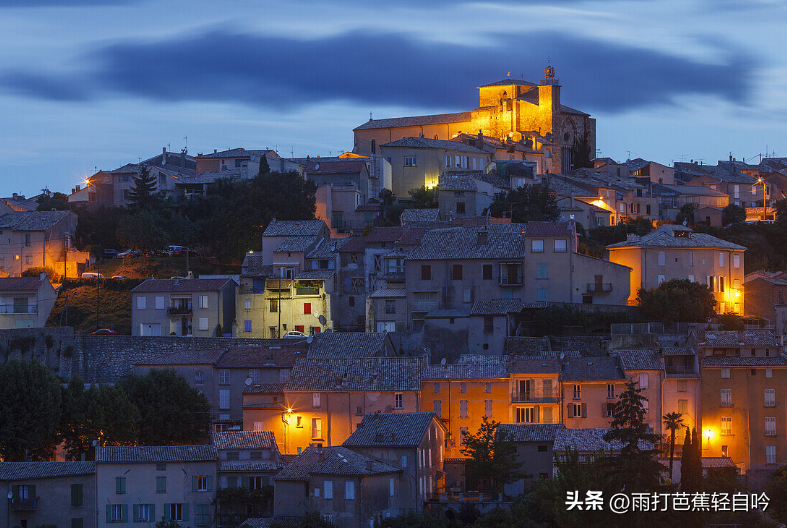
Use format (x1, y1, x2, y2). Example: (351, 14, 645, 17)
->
(0, 359, 62, 462)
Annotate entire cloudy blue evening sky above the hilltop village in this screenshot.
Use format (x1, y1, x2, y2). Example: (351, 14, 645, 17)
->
(0, 0, 787, 196)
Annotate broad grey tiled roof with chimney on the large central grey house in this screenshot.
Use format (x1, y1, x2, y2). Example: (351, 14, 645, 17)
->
(409, 224, 525, 260)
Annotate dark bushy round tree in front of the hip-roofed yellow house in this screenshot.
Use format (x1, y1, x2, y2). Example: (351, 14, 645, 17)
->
(637, 279, 716, 323)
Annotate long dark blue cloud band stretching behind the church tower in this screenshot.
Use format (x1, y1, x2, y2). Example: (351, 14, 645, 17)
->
(0, 32, 755, 112)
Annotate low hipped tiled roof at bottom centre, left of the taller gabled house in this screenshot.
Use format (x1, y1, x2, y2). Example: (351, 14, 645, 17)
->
(273, 447, 400, 481)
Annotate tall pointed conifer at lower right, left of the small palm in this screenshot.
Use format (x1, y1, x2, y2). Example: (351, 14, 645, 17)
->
(604, 381, 664, 491)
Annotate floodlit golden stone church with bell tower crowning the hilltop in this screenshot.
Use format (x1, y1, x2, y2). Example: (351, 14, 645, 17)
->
(353, 66, 596, 173)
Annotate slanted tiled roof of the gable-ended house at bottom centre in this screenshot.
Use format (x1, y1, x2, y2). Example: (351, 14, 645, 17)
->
(342, 412, 435, 447)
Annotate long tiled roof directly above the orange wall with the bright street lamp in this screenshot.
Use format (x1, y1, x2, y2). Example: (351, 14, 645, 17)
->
(285, 357, 425, 392)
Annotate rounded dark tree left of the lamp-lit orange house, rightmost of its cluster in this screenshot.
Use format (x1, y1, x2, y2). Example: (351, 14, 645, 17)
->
(119, 369, 210, 445)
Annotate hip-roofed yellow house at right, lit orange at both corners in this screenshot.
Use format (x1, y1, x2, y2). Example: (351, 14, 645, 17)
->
(607, 224, 746, 315)
